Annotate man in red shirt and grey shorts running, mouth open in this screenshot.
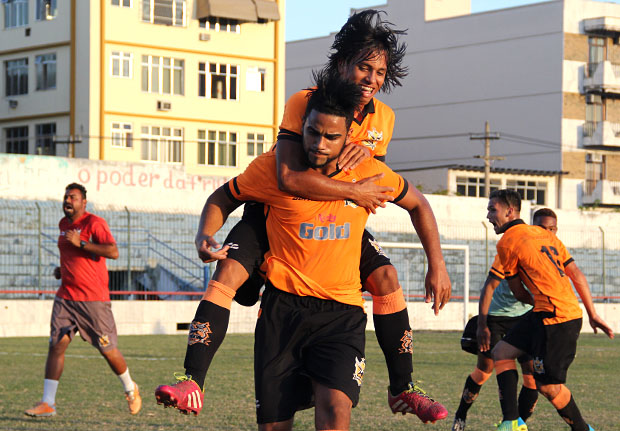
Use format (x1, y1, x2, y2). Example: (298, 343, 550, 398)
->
(24, 183, 142, 417)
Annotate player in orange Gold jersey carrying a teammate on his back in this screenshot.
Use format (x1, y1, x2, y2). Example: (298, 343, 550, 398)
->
(201, 73, 449, 430)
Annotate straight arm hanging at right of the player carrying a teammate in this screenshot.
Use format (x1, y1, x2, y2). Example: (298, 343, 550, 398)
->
(396, 184, 452, 315)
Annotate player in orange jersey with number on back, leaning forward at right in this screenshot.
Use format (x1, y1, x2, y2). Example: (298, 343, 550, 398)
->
(487, 190, 614, 431)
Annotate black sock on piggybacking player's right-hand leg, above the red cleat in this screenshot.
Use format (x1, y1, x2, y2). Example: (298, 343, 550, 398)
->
(373, 308, 413, 395)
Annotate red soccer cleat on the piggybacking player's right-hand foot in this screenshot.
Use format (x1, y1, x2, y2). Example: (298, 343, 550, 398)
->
(388, 383, 448, 423)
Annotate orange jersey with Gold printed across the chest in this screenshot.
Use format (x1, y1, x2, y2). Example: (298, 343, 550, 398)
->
(225, 152, 408, 306)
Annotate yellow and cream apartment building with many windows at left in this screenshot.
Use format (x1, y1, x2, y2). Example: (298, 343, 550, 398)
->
(0, 0, 285, 176)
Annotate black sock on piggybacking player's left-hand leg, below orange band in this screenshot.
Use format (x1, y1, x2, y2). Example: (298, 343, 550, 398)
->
(184, 300, 230, 389)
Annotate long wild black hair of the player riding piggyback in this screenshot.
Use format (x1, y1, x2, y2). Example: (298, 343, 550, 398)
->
(327, 9, 408, 93)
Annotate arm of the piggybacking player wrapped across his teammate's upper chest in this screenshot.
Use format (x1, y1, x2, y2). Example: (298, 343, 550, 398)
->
(276, 138, 393, 213)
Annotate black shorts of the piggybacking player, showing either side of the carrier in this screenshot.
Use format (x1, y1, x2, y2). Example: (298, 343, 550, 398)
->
(224, 207, 392, 284)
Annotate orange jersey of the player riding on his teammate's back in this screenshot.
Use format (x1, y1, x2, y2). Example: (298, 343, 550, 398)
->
(278, 90, 394, 161)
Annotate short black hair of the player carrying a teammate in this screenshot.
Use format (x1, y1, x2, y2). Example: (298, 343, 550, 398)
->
(304, 69, 362, 129)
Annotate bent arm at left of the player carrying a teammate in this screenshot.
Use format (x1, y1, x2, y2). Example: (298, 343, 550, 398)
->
(195, 184, 241, 263)
